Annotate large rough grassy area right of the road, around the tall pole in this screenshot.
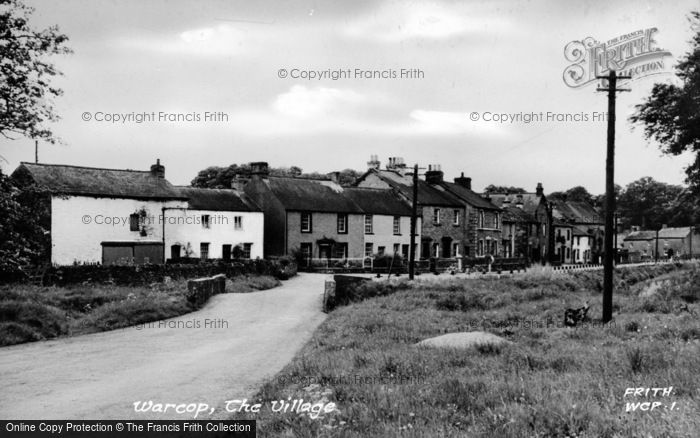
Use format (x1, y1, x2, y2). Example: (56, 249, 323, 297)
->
(242, 265, 700, 437)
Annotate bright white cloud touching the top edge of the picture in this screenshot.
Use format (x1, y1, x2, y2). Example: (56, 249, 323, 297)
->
(345, 3, 509, 42)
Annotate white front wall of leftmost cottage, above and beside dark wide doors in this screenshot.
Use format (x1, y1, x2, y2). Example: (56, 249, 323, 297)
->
(51, 196, 187, 265)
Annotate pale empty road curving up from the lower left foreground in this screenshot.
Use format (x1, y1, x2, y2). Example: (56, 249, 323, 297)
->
(0, 274, 325, 420)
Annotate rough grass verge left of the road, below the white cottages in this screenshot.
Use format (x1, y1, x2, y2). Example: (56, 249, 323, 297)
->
(0, 276, 280, 346)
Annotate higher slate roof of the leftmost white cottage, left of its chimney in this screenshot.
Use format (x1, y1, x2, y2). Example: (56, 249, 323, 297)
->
(12, 162, 182, 199)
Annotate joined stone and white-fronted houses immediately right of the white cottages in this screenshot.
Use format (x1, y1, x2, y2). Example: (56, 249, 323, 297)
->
(242, 162, 411, 266)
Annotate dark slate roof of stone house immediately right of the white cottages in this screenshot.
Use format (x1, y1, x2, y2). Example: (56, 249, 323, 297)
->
(263, 176, 364, 214)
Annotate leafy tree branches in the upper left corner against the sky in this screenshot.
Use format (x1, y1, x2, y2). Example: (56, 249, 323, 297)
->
(0, 0, 71, 143)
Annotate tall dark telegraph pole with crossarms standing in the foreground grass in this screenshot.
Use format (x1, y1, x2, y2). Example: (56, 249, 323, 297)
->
(597, 70, 631, 322)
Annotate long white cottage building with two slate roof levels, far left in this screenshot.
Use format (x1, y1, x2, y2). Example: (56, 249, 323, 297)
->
(12, 160, 263, 265)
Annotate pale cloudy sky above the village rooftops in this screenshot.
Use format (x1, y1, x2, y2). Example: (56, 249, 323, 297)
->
(0, 0, 698, 194)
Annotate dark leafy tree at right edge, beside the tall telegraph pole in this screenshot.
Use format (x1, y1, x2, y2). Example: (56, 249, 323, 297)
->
(630, 11, 700, 191)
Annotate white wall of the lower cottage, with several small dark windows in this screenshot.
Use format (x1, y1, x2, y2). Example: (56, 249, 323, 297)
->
(165, 209, 264, 259)
